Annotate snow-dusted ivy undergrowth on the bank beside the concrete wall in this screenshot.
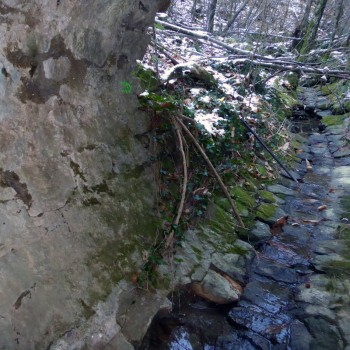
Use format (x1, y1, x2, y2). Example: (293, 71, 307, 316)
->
(137, 63, 298, 287)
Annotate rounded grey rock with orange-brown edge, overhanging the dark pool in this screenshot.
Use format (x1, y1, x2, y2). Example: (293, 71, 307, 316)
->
(192, 270, 243, 304)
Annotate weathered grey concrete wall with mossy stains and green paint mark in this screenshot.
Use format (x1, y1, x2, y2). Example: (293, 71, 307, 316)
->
(0, 0, 164, 350)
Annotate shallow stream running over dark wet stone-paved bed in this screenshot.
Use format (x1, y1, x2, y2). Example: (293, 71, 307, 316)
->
(141, 88, 350, 350)
